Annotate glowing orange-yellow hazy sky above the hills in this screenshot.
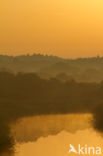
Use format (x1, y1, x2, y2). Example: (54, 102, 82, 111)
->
(0, 0, 103, 58)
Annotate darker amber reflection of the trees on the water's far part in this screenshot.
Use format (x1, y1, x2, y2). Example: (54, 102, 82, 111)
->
(11, 114, 92, 142)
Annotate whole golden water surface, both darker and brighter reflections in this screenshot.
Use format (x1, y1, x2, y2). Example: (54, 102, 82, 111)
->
(11, 114, 103, 156)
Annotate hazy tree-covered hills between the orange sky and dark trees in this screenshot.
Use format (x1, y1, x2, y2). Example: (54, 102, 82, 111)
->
(0, 54, 103, 82)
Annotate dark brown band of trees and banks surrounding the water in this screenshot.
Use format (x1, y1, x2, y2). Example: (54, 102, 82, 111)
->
(0, 71, 103, 152)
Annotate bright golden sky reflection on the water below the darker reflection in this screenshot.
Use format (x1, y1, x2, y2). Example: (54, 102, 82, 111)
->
(15, 129, 103, 156)
